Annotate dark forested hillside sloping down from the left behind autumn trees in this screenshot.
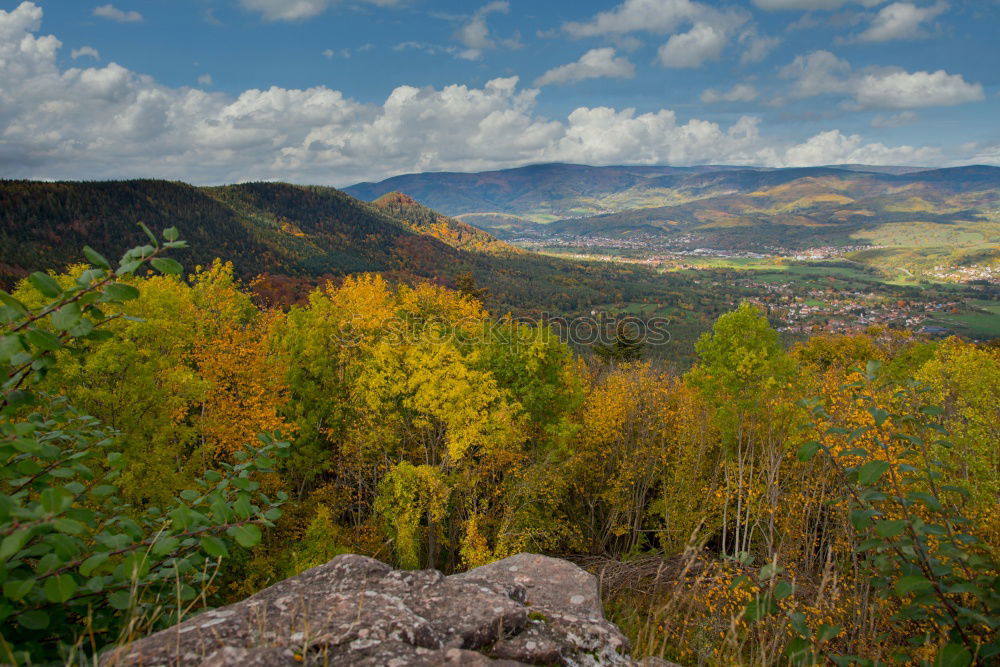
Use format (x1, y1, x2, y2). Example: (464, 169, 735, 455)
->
(0, 181, 772, 359)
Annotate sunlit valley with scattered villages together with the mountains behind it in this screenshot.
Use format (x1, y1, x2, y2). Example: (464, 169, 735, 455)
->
(345, 165, 1000, 340)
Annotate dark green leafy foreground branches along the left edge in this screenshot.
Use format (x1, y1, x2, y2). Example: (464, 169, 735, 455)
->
(0, 227, 288, 664)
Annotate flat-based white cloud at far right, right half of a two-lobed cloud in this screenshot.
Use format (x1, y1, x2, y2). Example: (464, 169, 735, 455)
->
(855, 70, 985, 109)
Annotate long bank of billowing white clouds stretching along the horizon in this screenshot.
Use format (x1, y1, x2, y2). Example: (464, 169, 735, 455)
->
(0, 2, 972, 185)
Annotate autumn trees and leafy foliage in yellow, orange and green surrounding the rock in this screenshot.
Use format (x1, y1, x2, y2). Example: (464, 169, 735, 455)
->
(0, 237, 1000, 664)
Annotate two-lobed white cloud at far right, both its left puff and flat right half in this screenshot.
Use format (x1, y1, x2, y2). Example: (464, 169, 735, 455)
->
(779, 51, 985, 109)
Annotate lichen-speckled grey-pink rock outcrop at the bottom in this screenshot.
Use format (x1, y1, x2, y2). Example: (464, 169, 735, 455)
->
(102, 554, 634, 667)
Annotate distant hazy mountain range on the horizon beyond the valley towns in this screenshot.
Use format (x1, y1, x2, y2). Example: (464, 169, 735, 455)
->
(344, 164, 1000, 250)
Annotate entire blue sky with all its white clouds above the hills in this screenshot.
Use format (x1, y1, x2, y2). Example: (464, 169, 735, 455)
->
(0, 0, 1000, 186)
